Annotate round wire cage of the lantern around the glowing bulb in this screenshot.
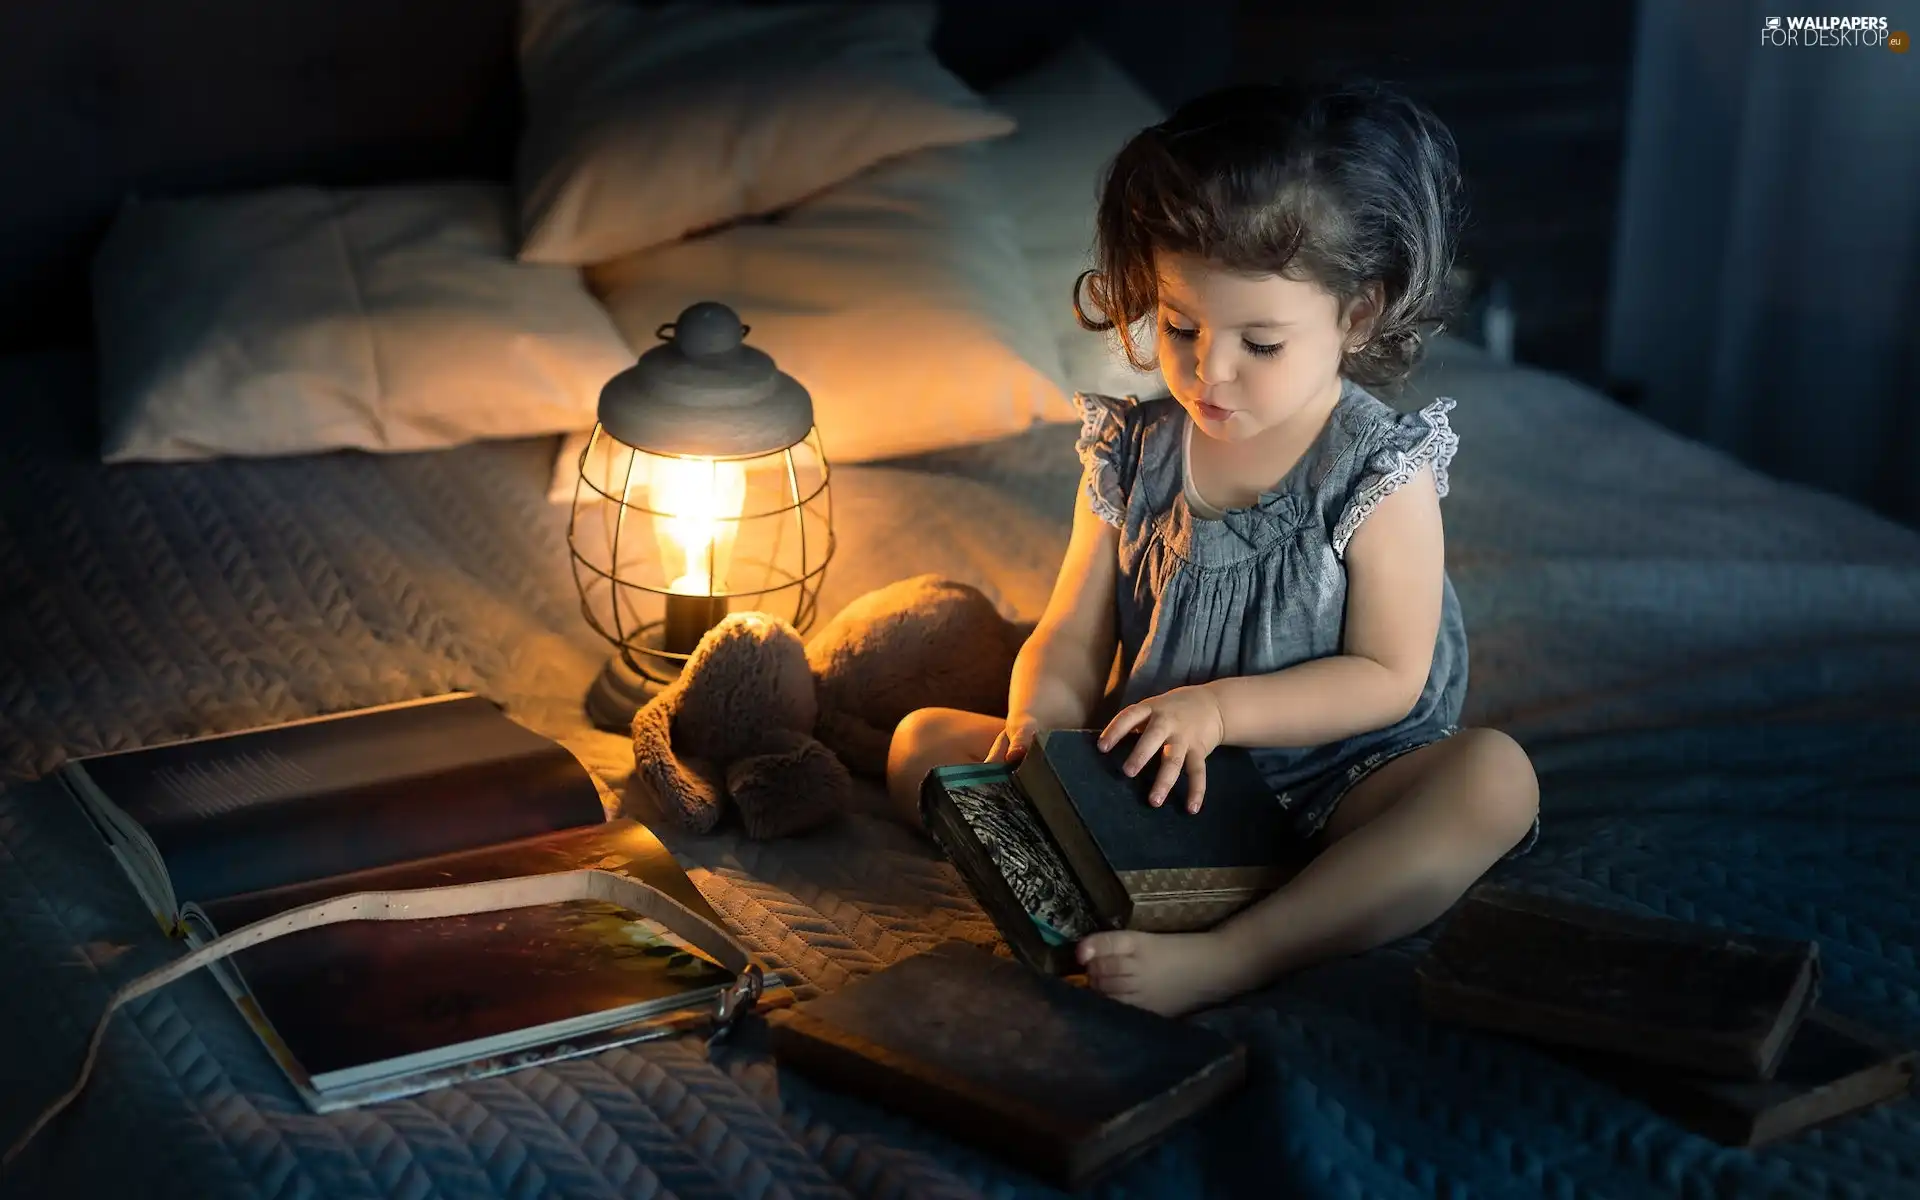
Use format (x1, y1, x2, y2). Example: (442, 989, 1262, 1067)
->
(566, 426, 833, 684)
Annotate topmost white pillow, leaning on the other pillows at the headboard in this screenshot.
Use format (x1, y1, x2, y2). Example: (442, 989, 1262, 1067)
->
(516, 0, 1014, 263)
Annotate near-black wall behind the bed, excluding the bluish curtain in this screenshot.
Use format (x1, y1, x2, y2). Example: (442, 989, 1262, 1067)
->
(0, 0, 1632, 380)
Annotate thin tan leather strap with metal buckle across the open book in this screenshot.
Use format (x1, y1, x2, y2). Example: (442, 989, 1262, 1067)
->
(0, 870, 764, 1167)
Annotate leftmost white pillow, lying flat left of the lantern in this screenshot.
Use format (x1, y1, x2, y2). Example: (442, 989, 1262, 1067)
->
(94, 184, 634, 463)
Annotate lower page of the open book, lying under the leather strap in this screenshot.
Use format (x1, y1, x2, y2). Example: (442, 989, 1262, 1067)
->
(188, 820, 733, 1098)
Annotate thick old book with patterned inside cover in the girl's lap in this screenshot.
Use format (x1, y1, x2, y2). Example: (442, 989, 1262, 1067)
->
(920, 730, 1308, 973)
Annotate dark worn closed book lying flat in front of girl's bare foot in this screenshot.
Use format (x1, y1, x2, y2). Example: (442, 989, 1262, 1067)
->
(768, 943, 1246, 1188)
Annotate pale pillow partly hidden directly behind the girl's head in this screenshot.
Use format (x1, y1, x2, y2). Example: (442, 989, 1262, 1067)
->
(989, 40, 1167, 396)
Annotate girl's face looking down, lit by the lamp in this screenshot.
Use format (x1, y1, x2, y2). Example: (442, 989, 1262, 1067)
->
(1154, 253, 1375, 442)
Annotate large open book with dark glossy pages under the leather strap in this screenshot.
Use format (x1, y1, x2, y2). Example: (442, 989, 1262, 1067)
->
(60, 695, 791, 1112)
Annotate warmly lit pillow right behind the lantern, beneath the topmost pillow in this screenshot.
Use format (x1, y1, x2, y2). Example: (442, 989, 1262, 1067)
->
(555, 144, 1077, 497)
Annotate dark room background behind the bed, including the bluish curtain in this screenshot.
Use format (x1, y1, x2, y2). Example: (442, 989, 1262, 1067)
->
(0, 0, 1920, 522)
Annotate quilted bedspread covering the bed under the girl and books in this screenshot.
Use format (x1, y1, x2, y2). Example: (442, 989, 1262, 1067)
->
(0, 344, 1920, 1200)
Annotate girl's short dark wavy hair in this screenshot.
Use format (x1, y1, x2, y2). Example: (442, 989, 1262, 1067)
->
(1073, 81, 1463, 386)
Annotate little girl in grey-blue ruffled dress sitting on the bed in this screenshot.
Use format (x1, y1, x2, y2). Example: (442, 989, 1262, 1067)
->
(887, 86, 1538, 1014)
